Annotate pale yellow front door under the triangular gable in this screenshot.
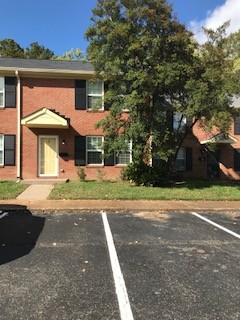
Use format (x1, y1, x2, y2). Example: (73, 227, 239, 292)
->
(38, 136, 58, 177)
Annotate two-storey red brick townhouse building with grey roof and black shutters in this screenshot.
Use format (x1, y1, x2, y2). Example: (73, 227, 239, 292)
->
(0, 58, 240, 180)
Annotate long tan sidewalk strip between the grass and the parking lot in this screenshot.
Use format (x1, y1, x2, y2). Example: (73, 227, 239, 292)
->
(0, 199, 240, 212)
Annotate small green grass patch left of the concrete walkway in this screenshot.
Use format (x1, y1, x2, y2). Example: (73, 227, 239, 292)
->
(0, 181, 27, 200)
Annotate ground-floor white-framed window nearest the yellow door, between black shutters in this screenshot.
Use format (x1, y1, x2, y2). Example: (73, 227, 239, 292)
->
(87, 137, 103, 165)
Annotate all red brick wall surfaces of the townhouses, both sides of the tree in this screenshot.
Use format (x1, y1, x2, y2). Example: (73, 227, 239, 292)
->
(0, 78, 240, 180)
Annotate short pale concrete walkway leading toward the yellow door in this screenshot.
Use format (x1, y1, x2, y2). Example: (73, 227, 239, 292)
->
(17, 184, 54, 200)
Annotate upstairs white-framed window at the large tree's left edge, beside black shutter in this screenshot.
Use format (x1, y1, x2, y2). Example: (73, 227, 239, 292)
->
(87, 82, 104, 110)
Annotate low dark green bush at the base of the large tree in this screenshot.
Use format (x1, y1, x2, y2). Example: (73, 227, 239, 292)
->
(120, 163, 167, 187)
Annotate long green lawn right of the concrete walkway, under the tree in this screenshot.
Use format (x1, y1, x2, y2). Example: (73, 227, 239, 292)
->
(49, 181, 240, 200)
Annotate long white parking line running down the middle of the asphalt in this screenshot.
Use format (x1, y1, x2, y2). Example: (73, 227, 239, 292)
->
(102, 212, 133, 320)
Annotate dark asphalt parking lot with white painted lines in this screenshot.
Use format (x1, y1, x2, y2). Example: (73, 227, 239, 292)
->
(0, 210, 240, 320)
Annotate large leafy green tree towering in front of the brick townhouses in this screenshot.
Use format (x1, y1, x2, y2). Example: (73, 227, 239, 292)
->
(86, 0, 239, 182)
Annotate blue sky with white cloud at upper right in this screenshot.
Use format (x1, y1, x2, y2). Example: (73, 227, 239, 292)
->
(0, 0, 240, 55)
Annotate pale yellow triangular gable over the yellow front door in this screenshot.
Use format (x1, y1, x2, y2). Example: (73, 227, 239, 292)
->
(21, 108, 69, 129)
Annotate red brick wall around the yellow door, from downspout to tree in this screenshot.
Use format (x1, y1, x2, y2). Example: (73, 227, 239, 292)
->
(22, 78, 124, 179)
